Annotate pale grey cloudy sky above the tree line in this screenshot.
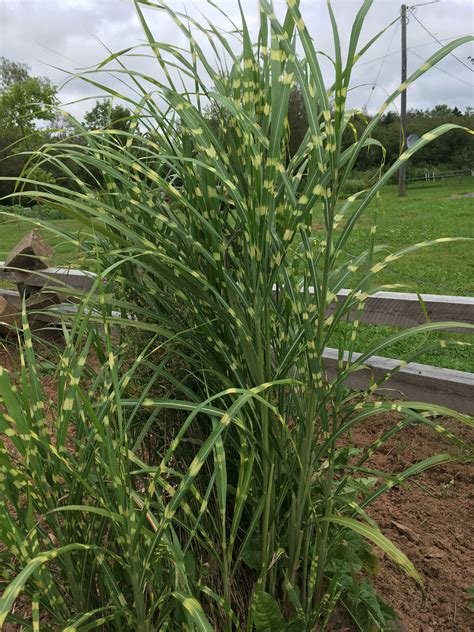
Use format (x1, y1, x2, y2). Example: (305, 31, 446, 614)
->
(0, 0, 474, 118)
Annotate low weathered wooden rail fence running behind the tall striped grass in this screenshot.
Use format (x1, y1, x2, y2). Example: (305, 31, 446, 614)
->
(0, 262, 474, 415)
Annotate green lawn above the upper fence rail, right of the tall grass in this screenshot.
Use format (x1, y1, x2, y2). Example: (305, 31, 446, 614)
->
(348, 177, 474, 296)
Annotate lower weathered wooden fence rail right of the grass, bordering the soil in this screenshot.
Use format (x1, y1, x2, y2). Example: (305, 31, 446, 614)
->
(323, 348, 474, 415)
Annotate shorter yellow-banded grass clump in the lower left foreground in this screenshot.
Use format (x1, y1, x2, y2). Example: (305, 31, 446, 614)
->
(0, 308, 282, 632)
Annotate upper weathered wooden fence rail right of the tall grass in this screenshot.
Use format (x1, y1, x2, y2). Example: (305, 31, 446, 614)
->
(328, 290, 474, 334)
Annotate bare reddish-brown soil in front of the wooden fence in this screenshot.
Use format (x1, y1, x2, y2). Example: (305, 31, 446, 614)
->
(0, 342, 474, 632)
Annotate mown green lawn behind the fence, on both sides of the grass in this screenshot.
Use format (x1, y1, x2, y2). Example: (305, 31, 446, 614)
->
(0, 177, 474, 371)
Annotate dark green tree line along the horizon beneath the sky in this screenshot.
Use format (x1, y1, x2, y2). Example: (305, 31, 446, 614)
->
(0, 57, 474, 198)
